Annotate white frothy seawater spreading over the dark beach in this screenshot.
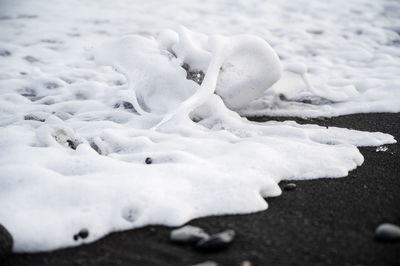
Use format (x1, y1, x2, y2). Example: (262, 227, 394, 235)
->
(0, 0, 400, 252)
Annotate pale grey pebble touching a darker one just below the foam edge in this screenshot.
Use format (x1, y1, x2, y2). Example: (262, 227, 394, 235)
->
(169, 225, 210, 244)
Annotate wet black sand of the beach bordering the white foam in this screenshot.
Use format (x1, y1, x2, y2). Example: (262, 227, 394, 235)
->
(0, 114, 400, 266)
